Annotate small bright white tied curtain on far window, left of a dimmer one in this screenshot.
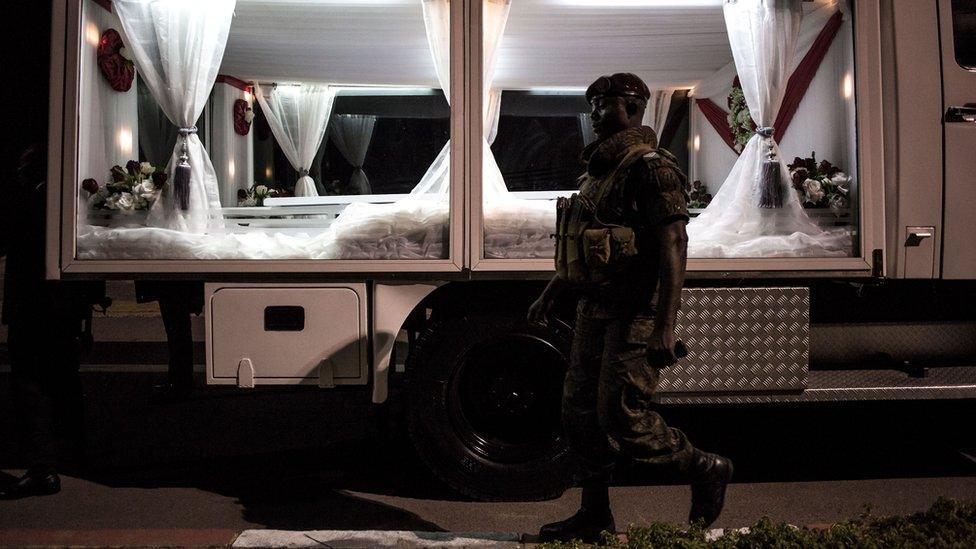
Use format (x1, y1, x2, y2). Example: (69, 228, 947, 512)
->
(255, 84, 335, 196)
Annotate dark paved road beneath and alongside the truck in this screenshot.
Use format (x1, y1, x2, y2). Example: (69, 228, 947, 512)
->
(0, 366, 976, 545)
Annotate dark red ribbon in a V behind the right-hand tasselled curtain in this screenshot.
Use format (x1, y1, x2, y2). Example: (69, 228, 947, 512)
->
(695, 11, 844, 154)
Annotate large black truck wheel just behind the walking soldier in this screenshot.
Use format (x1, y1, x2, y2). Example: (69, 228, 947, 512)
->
(406, 316, 572, 501)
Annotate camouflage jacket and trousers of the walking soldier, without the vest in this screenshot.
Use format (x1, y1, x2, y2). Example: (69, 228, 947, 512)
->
(562, 127, 693, 482)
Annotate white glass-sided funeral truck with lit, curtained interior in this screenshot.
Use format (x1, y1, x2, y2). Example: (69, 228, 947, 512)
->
(47, 0, 976, 499)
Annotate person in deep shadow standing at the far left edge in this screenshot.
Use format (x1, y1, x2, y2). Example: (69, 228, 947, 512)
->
(0, 144, 107, 499)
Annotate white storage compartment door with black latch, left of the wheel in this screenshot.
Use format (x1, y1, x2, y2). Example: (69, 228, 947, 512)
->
(207, 284, 366, 387)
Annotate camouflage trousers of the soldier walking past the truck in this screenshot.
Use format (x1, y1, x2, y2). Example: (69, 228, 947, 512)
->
(562, 298, 693, 483)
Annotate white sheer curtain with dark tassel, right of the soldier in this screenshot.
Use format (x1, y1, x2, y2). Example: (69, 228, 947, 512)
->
(688, 0, 850, 257)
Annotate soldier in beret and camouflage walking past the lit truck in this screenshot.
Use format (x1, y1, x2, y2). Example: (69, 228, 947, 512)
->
(528, 73, 732, 542)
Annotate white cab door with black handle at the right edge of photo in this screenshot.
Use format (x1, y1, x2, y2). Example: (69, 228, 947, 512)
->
(939, 0, 976, 279)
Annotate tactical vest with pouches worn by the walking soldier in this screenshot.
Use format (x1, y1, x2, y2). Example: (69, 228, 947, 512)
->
(553, 144, 655, 284)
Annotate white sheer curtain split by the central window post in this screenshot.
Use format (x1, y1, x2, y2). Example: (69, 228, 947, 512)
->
(410, 0, 511, 198)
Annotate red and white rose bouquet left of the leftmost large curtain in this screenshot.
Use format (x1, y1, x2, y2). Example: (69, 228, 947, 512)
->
(81, 160, 168, 214)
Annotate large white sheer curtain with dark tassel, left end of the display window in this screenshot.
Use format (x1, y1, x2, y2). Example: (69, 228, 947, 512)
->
(112, 0, 236, 232)
